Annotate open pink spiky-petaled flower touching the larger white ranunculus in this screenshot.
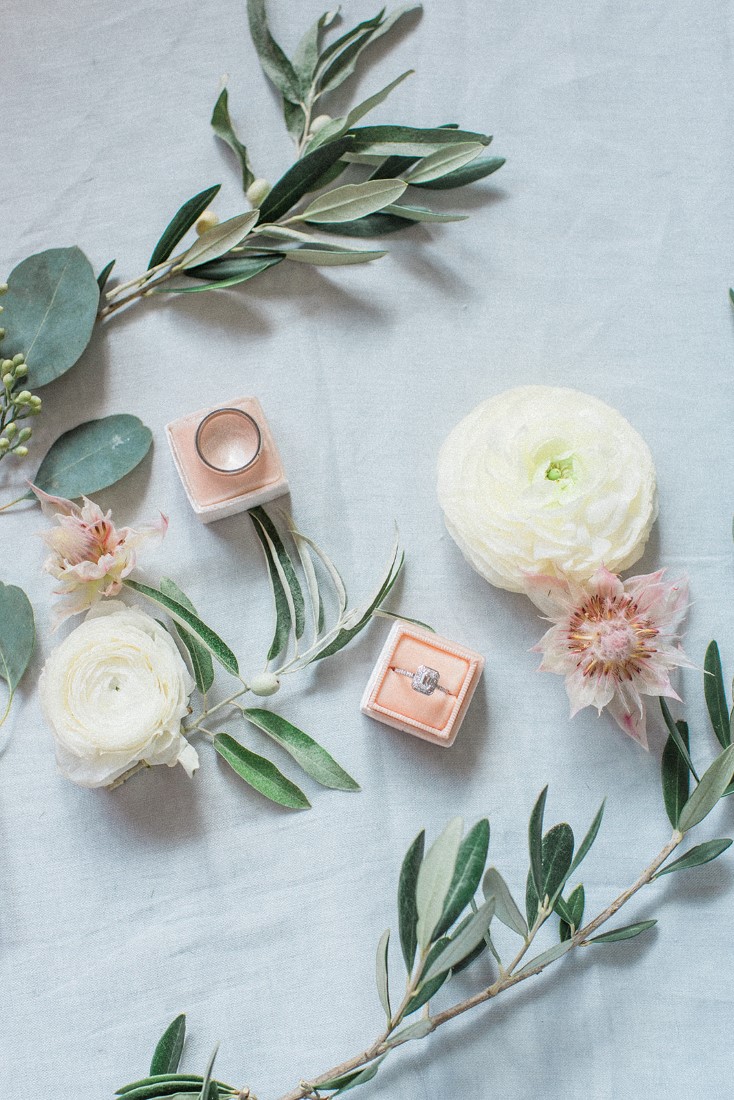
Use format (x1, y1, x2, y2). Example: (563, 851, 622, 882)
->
(527, 565, 690, 748)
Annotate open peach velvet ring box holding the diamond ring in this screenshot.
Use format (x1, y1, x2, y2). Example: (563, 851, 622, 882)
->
(361, 620, 484, 747)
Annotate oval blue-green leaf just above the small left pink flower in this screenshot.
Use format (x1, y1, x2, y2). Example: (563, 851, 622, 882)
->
(26, 413, 153, 501)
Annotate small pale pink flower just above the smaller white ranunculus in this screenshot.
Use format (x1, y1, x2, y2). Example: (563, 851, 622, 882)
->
(31, 485, 168, 627)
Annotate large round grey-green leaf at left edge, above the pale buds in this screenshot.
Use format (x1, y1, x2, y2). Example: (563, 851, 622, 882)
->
(2, 248, 99, 391)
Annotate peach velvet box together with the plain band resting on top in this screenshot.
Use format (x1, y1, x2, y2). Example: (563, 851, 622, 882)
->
(166, 397, 288, 524)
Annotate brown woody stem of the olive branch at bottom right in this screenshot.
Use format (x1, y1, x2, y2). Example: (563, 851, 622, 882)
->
(272, 829, 683, 1100)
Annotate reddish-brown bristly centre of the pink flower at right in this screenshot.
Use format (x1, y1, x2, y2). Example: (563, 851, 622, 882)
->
(569, 596, 659, 681)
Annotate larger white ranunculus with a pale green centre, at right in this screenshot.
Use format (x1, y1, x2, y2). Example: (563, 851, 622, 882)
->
(438, 386, 657, 595)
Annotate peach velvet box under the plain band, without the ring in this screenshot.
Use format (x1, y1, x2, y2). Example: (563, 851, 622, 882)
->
(166, 397, 288, 524)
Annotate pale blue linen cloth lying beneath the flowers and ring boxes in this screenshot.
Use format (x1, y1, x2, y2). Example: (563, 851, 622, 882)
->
(0, 0, 734, 1100)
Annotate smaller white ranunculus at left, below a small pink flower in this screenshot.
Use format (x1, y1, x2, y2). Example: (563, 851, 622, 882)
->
(39, 601, 199, 787)
